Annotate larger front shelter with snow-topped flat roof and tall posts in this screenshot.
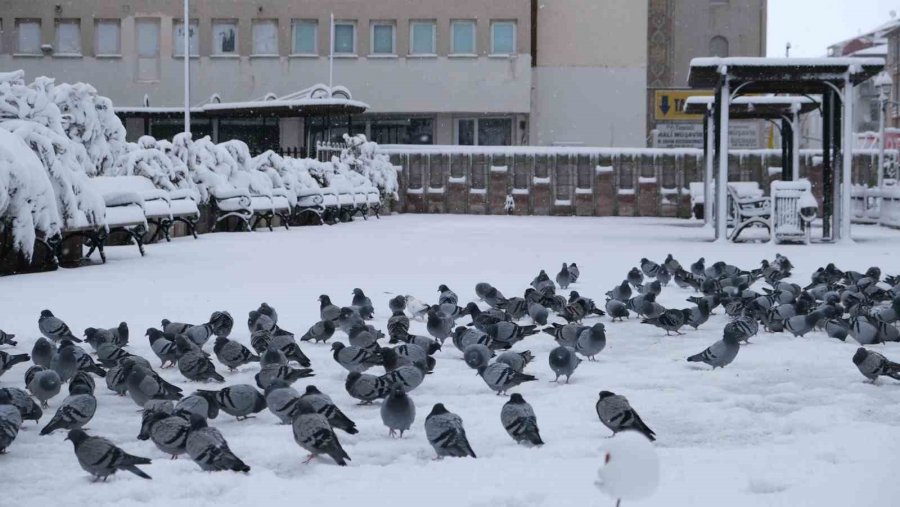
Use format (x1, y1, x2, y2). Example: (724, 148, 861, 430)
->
(688, 57, 884, 242)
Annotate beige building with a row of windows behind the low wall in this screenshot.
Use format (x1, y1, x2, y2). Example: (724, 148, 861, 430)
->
(0, 0, 766, 150)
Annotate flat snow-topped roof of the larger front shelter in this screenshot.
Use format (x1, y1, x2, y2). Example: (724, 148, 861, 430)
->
(688, 57, 884, 95)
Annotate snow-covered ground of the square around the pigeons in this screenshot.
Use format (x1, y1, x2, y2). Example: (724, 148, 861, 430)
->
(0, 215, 900, 507)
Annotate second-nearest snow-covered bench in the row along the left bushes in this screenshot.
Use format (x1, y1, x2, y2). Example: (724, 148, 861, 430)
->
(92, 176, 200, 243)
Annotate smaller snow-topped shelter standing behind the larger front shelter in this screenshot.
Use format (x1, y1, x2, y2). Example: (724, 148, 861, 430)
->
(683, 95, 819, 224)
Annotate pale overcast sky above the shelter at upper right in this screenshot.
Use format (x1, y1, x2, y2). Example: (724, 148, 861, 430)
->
(768, 0, 900, 56)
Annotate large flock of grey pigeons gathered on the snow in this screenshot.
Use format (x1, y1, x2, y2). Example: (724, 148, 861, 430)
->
(0, 255, 900, 480)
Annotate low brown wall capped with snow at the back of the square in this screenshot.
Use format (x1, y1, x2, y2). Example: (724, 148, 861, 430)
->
(376, 145, 898, 218)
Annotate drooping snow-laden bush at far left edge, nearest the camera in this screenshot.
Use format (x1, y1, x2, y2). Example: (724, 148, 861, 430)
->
(0, 129, 60, 260)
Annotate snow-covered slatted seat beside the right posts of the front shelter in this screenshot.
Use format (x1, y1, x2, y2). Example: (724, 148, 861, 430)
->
(770, 179, 818, 243)
